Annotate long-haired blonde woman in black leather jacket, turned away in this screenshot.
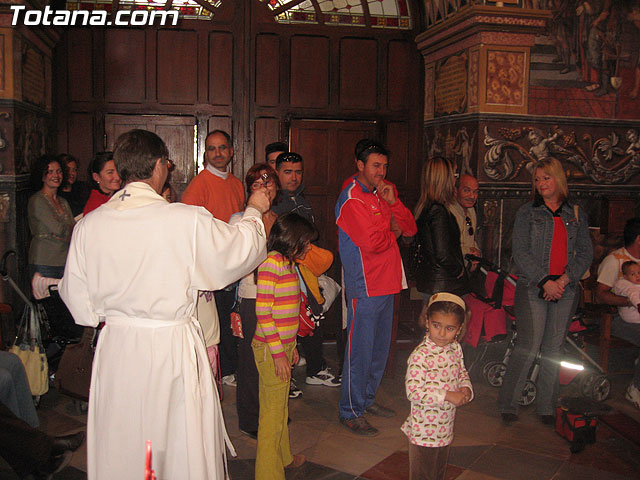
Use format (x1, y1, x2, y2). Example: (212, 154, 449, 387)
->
(414, 157, 469, 301)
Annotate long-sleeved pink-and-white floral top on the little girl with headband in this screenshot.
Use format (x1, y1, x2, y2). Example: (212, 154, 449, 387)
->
(402, 336, 473, 447)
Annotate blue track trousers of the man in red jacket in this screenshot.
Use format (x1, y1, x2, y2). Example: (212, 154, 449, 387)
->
(340, 295, 393, 419)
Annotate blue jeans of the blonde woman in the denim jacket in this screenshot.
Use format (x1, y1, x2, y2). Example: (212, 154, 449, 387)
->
(498, 281, 576, 415)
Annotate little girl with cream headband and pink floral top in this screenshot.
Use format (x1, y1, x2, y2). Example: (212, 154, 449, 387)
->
(402, 292, 473, 480)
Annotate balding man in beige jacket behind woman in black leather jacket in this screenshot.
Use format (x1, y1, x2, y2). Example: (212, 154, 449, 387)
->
(449, 174, 482, 271)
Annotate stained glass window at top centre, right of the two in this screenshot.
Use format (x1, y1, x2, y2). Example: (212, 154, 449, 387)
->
(261, 0, 411, 30)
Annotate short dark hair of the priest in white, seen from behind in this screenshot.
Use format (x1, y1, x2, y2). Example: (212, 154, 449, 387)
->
(113, 129, 169, 183)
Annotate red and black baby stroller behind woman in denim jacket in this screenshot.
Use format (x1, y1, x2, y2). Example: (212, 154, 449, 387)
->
(465, 255, 611, 406)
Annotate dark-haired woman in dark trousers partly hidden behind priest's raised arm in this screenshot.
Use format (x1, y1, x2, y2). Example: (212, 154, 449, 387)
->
(229, 163, 280, 438)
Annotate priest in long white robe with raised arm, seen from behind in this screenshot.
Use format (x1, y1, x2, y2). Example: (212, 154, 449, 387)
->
(60, 130, 270, 480)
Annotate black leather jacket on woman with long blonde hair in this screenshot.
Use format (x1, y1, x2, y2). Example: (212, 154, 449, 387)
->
(416, 203, 469, 295)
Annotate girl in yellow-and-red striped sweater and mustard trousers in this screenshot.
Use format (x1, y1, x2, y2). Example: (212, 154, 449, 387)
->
(251, 213, 317, 480)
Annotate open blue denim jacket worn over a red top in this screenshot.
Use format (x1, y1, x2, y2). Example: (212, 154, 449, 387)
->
(511, 201, 593, 287)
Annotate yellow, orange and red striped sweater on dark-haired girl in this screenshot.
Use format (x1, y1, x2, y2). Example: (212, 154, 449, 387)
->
(253, 251, 300, 358)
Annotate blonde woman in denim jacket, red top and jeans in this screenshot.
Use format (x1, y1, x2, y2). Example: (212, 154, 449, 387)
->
(498, 157, 593, 424)
